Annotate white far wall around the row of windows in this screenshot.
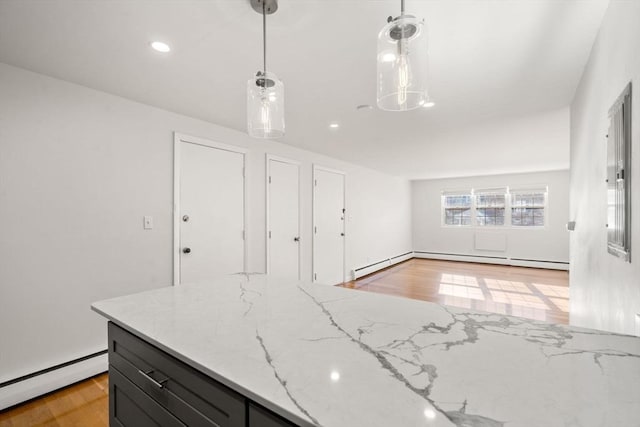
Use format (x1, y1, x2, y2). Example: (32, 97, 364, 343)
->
(412, 171, 569, 262)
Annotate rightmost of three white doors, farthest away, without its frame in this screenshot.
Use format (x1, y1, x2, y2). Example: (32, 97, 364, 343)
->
(313, 167, 345, 285)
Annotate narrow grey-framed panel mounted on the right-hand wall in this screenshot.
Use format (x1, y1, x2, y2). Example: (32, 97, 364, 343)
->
(607, 83, 631, 261)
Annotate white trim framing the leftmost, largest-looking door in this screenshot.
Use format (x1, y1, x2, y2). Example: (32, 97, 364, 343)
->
(173, 132, 249, 286)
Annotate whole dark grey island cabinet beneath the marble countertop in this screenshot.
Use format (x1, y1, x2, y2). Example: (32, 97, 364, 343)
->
(109, 322, 295, 427)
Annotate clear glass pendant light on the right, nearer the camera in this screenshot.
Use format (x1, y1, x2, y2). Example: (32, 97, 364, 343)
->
(377, 0, 427, 111)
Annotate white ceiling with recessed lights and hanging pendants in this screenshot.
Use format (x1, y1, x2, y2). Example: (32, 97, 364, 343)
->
(0, 0, 608, 178)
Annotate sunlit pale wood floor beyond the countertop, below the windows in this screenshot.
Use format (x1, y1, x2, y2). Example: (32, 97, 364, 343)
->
(341, 259, 569, 324)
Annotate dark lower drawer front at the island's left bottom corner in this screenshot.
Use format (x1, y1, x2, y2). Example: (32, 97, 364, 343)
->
(109, 367, 184, 427)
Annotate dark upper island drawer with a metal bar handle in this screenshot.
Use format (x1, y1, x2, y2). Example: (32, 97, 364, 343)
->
(109, 323, 246, 427)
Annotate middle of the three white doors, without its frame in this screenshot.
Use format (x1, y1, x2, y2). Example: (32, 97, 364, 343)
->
(267, 158, 300, 279)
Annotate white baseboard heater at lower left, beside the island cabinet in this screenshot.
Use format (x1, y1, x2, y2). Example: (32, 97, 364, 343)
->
(0, 353, 109, 411)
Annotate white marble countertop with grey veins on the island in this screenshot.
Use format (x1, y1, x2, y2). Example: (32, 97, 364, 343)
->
(92, 274, 640, 427)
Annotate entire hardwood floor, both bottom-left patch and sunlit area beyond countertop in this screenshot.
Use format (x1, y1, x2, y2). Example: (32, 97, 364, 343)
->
(0, 259, 569, 427)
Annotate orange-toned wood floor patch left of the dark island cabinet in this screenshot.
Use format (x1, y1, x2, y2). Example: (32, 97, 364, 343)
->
(0, 374, 109, 427)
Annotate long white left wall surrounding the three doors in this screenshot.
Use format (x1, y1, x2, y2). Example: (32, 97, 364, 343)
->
(0, 64, 412, 388)
